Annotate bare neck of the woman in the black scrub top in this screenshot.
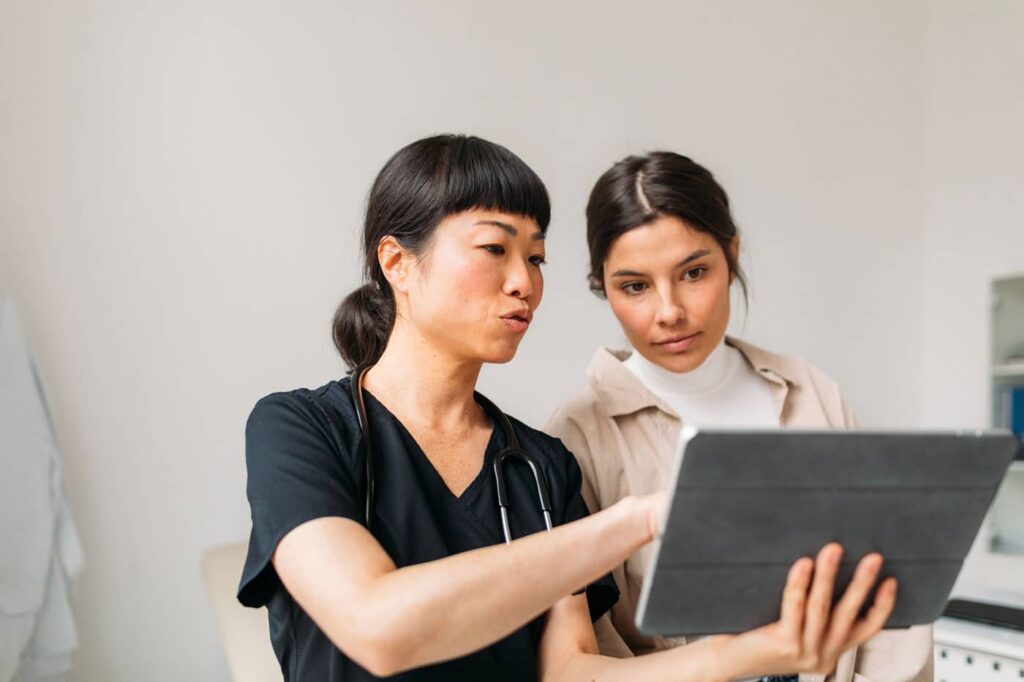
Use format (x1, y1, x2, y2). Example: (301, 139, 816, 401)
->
(364, 317, 484, 429)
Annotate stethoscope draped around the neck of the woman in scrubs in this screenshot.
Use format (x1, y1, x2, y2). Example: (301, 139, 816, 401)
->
(351, 365, 551, 543)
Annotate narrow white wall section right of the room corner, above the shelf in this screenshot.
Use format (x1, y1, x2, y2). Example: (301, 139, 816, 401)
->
(921, 0, 1024, 426)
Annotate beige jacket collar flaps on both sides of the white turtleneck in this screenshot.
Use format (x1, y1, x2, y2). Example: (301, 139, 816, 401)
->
(587, 336, 796, 420)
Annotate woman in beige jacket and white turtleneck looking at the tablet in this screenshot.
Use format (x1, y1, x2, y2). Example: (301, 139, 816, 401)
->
(547, 152, 933, 682)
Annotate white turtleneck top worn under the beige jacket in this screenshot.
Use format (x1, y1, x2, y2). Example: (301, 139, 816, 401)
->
(623, 341, 779, 428)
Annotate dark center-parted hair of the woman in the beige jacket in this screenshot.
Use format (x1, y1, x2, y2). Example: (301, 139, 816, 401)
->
(587, 152, 748, 299)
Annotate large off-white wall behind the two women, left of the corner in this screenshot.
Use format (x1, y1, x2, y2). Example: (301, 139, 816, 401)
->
(0, 0, 958, 681)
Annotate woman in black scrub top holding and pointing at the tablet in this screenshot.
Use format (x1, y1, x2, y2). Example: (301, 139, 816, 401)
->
(239, 135, 892, 682)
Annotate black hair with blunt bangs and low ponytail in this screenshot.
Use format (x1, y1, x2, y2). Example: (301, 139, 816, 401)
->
(333, 135, 551, 368)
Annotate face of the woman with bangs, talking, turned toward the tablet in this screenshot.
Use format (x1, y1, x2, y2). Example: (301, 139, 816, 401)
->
(406, 209, 545, 363)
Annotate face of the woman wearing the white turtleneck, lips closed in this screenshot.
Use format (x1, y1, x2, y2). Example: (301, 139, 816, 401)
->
(604, 216, 738, 372)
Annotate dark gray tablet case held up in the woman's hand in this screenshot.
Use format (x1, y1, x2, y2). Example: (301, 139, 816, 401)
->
(636, 429, 1020, 635)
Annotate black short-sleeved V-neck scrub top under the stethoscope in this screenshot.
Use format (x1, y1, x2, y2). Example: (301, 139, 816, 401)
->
(238, 377, 618, 682)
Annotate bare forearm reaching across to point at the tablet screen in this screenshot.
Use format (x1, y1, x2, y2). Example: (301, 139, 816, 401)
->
(366, 499, 652, 670)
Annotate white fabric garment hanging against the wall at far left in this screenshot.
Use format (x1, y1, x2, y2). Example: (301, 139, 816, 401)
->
(0, 296, 83, 682)
